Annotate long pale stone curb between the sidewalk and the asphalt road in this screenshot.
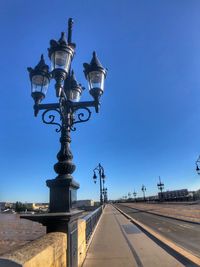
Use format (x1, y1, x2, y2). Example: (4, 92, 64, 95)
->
(113, 205, 200, 266)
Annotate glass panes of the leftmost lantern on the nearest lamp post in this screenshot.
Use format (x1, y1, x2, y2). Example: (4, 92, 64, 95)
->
(32, 75, 49, 95)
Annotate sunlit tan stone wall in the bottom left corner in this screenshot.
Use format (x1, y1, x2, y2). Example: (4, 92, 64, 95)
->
(0, 232, 67, 267)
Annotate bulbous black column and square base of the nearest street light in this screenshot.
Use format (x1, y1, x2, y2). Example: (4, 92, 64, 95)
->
(46, 105, 79, 212)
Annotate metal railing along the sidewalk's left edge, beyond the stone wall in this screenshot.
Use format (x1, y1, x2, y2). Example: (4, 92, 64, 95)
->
(84, 206, 104, 244)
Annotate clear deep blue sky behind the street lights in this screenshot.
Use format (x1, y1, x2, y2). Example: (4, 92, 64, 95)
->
(0, 0, 200, 202)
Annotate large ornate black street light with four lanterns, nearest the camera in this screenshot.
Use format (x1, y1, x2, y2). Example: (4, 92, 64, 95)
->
(28, 18, 106, 213)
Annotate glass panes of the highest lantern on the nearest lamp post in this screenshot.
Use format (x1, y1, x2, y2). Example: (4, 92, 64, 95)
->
(51, 51, 71, 73)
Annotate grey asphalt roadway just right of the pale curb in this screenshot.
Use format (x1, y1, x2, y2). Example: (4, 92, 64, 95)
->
(116, 204, 200, 257)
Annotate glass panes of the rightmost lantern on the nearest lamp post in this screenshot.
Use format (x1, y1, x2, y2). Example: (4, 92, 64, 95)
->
(88, 71, 104, 91)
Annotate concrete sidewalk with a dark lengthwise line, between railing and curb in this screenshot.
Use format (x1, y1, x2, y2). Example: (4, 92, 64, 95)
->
(83, 205, 185, 267)
